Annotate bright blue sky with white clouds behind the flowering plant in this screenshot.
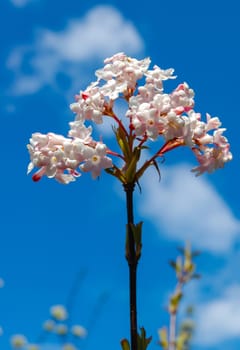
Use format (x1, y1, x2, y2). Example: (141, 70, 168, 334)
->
(0, 0, 240, 350)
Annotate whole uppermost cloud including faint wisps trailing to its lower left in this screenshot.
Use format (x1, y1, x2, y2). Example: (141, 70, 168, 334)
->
(7, 5, 143, 95)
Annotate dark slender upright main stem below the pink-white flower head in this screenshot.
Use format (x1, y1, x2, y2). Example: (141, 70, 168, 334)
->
(123, 183, 138, 350)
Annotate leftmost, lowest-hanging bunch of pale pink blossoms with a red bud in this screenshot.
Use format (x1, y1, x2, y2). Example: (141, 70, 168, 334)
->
(28, 130, 112, 184)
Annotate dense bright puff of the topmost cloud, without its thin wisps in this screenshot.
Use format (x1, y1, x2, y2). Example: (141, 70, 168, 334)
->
(40, 6, 142, 61)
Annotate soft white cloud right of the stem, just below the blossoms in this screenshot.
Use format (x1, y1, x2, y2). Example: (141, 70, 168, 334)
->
(139, 165, 240, 253)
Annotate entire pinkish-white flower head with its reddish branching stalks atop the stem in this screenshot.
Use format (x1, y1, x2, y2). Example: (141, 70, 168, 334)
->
(28, 53, 232, 184)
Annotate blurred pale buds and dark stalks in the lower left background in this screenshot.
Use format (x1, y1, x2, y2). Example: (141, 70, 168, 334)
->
(10, 269, 109, 350)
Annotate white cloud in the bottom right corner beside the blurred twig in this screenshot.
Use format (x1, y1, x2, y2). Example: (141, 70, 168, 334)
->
(195, 285, 240, 347)
